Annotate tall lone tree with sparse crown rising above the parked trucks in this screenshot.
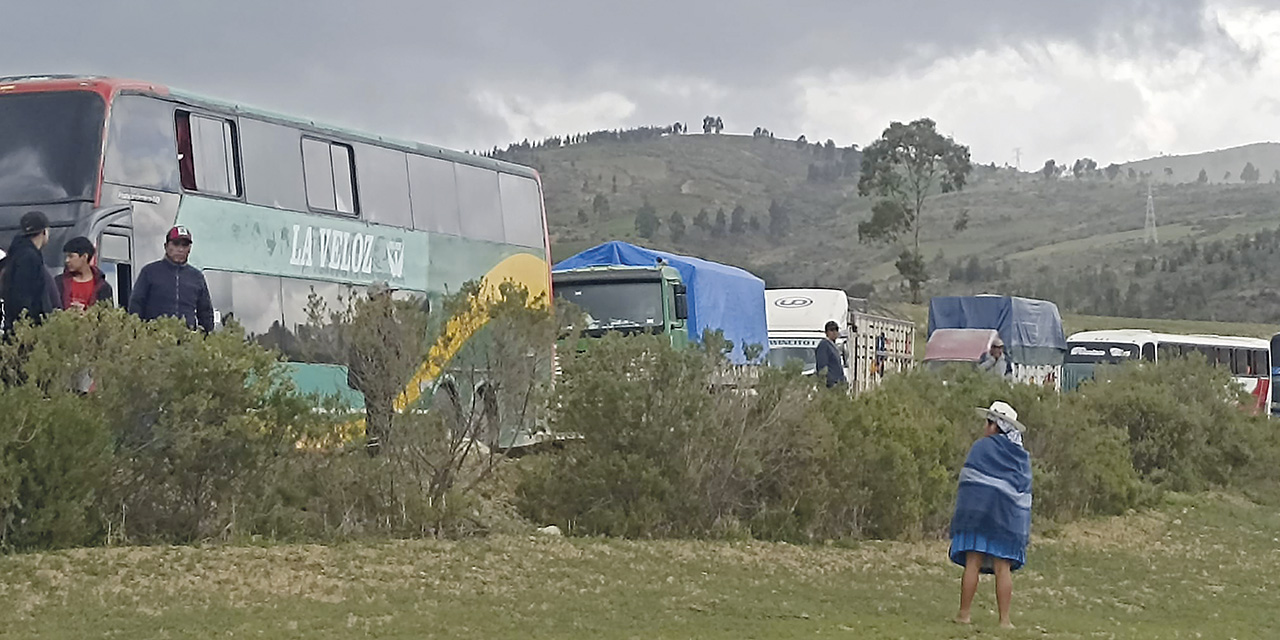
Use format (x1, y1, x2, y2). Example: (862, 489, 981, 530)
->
(858, 118, 973, 302)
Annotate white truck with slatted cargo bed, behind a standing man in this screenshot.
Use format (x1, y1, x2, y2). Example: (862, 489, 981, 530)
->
(764, 289, 915, 392)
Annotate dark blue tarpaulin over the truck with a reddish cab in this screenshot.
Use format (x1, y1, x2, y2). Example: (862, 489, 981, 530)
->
(929, 296, 1066, 365)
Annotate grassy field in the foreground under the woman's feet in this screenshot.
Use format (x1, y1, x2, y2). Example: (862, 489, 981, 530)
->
(0, 494, 1280, 639)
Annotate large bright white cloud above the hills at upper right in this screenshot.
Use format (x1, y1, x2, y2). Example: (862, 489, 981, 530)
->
(797, 3, 1280, 169)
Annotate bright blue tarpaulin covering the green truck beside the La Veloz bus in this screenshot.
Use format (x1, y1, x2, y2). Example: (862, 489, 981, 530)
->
(552, 241, 769, 364)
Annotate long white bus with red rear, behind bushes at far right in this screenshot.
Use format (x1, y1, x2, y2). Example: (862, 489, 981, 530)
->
(1062, 329, 1271, 415)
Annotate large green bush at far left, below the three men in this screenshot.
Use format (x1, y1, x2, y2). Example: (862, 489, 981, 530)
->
(0, 307, 314, 545)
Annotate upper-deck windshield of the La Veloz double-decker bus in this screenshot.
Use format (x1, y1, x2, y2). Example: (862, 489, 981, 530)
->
(0, 91, 105, 206)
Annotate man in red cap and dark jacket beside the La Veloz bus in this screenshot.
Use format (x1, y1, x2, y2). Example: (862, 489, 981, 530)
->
(129, 227, 214, 333)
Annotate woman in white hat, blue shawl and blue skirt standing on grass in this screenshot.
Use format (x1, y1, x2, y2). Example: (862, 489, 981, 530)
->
(948, 402, 1032, 628)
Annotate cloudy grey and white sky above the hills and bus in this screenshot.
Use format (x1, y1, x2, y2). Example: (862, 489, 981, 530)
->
(0, 0, 1280, 169)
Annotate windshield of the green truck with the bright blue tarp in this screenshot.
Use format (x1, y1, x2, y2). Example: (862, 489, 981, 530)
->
(556, 282, 663, 332)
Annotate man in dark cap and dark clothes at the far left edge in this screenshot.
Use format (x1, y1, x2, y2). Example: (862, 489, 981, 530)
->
(0, 211, 59, 333)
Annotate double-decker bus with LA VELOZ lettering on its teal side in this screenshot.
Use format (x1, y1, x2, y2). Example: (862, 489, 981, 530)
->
(0, 76, 550, 435)
